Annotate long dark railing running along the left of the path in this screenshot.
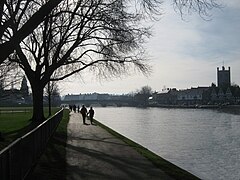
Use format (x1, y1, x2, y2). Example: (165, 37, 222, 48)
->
(0, 109, 63, 180)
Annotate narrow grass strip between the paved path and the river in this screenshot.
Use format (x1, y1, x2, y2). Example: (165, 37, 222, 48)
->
(94, 119, 200, 180)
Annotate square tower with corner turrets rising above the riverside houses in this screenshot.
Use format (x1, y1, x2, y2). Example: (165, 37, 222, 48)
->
(217, 66, 231, 87)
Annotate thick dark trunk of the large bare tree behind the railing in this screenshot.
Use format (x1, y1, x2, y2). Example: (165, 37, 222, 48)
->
(32, 86, 45, 122)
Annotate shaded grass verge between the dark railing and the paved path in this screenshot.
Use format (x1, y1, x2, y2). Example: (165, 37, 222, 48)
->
(27, 110, 69, 180)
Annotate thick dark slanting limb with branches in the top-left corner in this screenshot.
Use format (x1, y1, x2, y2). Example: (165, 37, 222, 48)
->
(0, 0, 62, 64)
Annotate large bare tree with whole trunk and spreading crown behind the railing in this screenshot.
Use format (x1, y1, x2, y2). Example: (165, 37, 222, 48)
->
(9, 0, 158, 120)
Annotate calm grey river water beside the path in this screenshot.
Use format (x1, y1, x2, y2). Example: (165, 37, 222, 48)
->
(95, 107, 240, 180)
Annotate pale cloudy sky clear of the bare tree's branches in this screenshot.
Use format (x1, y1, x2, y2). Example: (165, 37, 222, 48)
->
(60, 0, 240, 95)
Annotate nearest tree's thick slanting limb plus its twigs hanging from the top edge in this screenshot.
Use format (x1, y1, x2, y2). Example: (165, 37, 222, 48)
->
(0, 0, 220, 64)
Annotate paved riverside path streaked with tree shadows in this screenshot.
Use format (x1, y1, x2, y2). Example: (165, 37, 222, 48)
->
(67, 112, 171, 180)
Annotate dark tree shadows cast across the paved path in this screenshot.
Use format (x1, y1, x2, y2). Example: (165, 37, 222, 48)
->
(67, 138, 165, 179)
